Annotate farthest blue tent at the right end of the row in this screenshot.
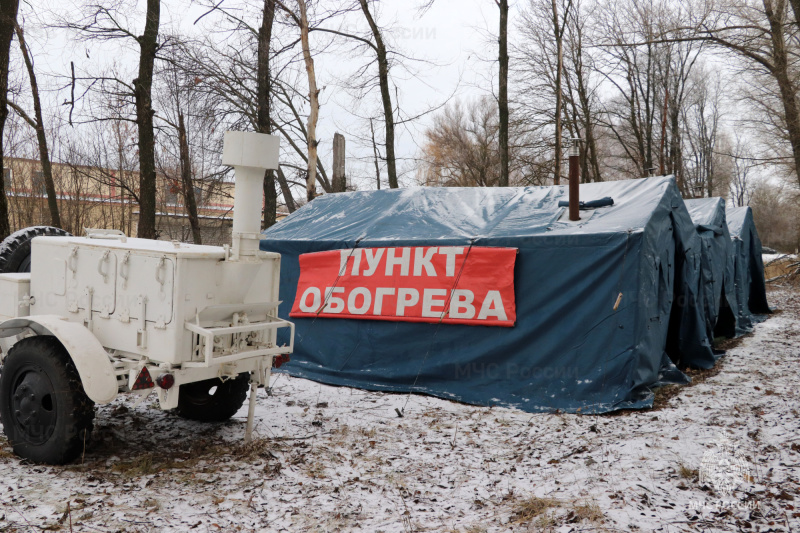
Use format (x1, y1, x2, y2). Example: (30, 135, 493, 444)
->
(726, 206, 771, 334)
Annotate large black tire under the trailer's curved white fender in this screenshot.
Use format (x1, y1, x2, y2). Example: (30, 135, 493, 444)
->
(0, 336, 94, 464)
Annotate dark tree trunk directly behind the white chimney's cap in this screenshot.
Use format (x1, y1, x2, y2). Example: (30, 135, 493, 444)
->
(256, 0, 278, 229)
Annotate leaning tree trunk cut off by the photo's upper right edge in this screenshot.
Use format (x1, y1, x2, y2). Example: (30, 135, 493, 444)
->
(763, 0, 800, 182)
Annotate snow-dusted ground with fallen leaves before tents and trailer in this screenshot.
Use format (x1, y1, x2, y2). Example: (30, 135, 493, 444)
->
(0, 288, 800, 533)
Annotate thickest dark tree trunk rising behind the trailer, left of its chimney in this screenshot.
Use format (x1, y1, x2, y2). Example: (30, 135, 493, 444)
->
(133, 0, 161, 239)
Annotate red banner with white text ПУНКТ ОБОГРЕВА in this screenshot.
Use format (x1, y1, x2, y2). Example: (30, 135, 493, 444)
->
(289, 246, 517, 327)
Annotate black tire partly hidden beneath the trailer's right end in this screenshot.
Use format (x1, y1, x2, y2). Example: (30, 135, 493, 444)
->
(178, 373, 250, 422)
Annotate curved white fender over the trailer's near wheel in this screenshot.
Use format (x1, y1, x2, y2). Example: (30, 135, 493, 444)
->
(0, 315, 118, 404)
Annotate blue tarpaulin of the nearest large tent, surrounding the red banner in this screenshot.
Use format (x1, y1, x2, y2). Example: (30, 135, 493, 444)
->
(261, 177, 715, 413)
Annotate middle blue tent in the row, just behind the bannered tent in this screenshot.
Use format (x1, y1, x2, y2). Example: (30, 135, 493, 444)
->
(686, 198, 741, 337)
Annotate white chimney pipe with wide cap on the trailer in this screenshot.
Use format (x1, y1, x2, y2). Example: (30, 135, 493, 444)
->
(222, 131, 280, 260)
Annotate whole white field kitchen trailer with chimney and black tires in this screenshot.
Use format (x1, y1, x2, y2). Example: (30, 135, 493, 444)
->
(0, 132, 294, 463)
